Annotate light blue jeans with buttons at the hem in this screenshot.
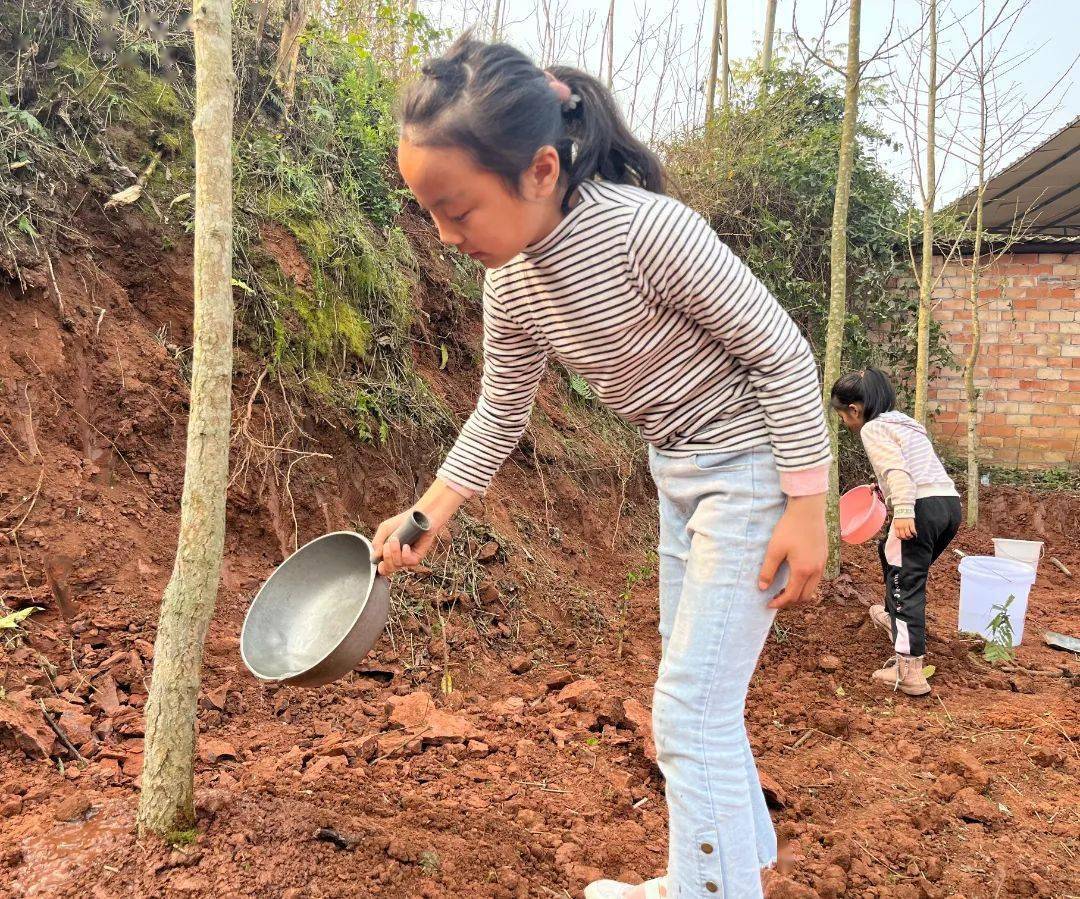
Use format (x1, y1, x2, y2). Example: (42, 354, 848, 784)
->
(649, 447, 787, 899)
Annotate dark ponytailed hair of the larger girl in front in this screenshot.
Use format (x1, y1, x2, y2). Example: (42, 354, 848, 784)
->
(400, 33, 666, 212)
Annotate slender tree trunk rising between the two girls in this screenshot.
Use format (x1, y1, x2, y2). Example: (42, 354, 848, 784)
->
(824, 0, 862, 577)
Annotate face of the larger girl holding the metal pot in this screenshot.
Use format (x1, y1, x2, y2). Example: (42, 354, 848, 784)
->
(397, 136, 563, 268)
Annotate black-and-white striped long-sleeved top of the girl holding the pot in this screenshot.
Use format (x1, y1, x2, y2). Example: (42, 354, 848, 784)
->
(438, 182, 829, 492)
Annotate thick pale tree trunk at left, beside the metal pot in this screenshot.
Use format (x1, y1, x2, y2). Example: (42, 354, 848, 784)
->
(138, 0, 235, 836)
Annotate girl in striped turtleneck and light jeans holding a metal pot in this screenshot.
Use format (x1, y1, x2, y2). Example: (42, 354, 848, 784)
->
(375, 37, 829, 899)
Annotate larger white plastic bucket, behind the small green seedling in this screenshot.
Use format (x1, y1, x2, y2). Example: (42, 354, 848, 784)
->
(957, 555, 1035, 646)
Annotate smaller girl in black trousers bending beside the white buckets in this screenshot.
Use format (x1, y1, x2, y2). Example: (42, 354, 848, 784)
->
(832, 368, 960, 696)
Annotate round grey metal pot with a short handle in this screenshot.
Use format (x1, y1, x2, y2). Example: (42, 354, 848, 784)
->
(240, 511, 431, 687)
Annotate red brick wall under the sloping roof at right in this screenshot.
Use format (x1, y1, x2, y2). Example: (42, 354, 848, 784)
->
(930, 253, 1080, 468)
